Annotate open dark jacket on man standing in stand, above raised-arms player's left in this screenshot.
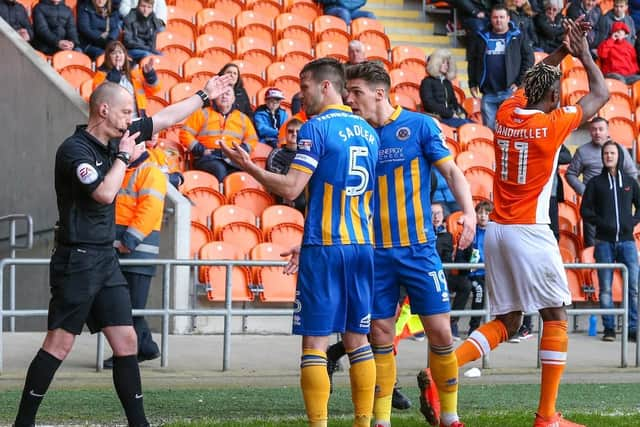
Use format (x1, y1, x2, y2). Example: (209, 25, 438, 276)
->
(467, 22, 533, 91)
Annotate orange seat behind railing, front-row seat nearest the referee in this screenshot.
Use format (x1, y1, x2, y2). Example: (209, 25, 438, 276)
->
(200, 241, 254, 301)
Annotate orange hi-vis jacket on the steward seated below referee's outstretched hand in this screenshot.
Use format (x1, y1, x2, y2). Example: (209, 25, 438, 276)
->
(180, 107, 258, 151)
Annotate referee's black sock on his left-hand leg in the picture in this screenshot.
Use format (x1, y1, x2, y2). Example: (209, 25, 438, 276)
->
(15, 349, 62, 427)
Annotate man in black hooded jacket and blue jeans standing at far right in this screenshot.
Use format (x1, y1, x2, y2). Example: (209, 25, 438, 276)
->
(580, 141, 640, 341)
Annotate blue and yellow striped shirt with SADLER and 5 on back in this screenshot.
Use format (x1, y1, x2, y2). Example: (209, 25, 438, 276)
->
(291, 105, 379, 245)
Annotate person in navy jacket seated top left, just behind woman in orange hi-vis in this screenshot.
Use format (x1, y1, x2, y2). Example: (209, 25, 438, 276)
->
(78, 0, 122, 60)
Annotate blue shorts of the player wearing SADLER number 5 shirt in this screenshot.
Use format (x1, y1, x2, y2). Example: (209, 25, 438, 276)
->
(293, 245, 373, 336)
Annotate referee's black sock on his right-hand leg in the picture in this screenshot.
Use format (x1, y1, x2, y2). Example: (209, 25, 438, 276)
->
(113, 354, 149, 427)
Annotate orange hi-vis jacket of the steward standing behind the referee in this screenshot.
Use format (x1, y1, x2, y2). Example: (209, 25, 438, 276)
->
(114, 153, 167, 275)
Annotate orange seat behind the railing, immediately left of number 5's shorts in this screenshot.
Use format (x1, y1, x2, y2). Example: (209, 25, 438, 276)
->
(250, 243, 297, 302)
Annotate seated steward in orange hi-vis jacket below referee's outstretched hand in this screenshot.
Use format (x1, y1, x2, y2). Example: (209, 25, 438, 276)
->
(180, 88, 258, 182)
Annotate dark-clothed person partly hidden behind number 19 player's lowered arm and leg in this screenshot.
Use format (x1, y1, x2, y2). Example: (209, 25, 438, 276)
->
(431, 203, 471, 341)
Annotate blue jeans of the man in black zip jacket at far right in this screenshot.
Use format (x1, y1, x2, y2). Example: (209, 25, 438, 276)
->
(594, 240, 638, 331)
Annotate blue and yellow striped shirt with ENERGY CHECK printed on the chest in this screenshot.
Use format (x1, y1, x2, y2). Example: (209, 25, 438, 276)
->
(373, 107, 451, 248)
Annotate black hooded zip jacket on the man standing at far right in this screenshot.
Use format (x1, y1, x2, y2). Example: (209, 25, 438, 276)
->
(580, 144, 640, 242)
